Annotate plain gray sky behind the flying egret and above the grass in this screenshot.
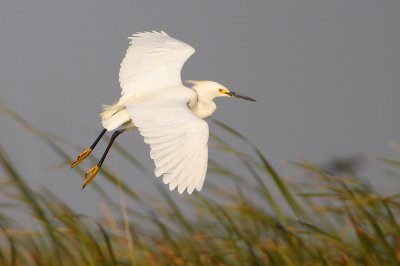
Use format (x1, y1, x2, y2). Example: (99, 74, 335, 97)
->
(0, 0, 400, 214)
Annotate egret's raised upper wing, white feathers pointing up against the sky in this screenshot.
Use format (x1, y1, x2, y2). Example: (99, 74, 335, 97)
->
(119, 31, 195, 98)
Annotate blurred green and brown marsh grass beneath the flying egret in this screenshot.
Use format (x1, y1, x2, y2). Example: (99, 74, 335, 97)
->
(0, 109, 400, 265)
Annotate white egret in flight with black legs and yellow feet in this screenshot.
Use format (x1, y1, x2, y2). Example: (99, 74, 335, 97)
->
(71, 31, 255, 194)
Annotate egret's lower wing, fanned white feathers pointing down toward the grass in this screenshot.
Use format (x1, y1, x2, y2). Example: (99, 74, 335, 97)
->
(126, 92, 209, 194)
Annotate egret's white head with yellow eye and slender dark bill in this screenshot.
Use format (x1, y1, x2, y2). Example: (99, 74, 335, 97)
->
(186, 80, 256, 102)
